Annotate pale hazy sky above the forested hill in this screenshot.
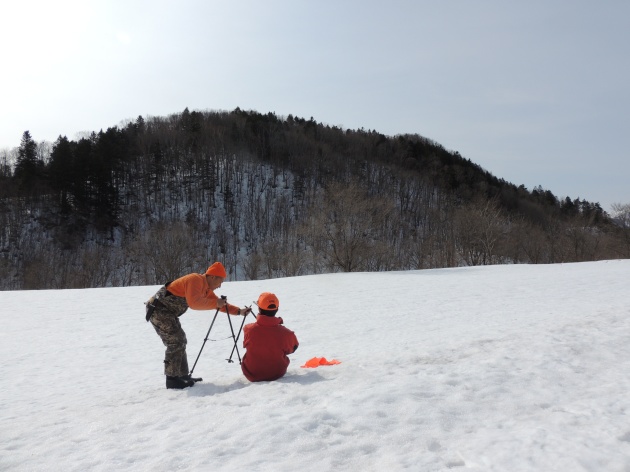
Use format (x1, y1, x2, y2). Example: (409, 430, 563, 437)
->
(0, 0, 630, 211)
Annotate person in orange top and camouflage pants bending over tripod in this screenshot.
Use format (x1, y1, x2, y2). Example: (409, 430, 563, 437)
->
(147, 262, 251, 389)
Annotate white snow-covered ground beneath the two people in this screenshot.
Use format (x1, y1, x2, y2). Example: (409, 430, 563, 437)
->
(0, 260, 630, 472)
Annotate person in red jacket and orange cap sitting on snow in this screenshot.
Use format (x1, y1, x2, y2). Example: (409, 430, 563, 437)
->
(241, 292, 299, 382)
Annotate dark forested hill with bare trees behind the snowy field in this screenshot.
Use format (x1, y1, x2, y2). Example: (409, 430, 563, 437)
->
(0, 108, 630, 290)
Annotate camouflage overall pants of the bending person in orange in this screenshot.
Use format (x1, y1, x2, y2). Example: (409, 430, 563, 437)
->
(150, 287, 188, 377)
